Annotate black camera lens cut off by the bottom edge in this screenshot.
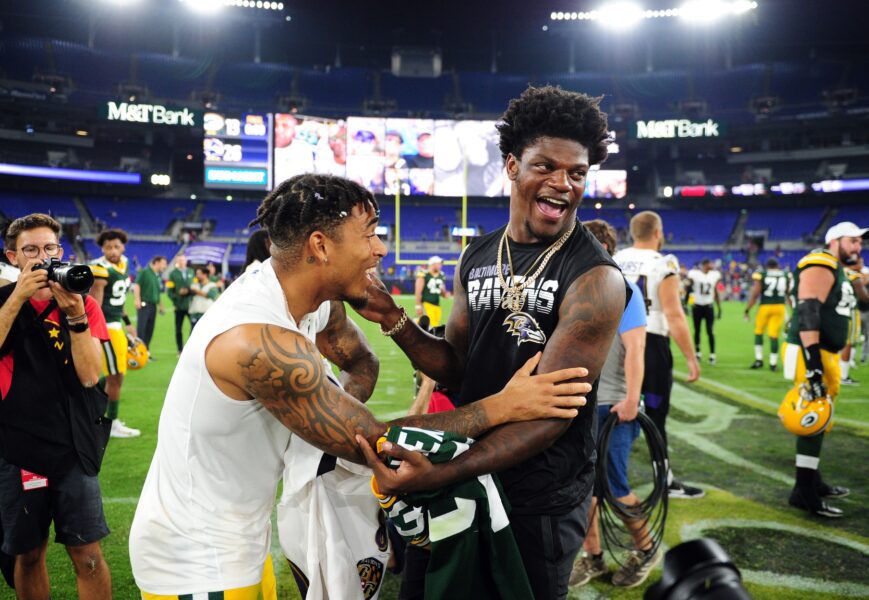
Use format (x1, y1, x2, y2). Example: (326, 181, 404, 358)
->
(643, 538, 751, 600)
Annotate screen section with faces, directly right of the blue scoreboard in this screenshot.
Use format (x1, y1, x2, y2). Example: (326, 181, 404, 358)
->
(274, 113, 347, 184)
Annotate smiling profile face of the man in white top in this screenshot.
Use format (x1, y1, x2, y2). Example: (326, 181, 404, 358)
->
(329, 204, 386, 308)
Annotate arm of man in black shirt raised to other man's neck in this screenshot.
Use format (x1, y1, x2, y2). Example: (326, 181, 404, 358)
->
(358, 254, 468, 390)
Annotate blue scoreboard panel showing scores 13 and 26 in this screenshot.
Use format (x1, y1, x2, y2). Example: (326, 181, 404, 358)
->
(202, 112, 272, 190)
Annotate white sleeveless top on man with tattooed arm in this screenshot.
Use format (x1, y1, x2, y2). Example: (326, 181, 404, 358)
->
(130, 260, 329, 595)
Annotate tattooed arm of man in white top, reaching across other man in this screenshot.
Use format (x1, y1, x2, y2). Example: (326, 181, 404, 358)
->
(205, 324, 588, 464)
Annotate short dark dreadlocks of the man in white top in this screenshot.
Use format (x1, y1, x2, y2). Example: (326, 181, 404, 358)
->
(249, 173, 380, 259)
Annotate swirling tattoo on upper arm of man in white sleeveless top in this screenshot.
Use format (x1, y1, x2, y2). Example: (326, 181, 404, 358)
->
(238, 325, 383, 460)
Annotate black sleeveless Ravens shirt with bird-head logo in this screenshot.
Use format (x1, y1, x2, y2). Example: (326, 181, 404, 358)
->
(458, 223, 618, 514)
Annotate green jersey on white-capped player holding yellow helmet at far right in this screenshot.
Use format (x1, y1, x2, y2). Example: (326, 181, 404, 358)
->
(788, 250, 857, 352)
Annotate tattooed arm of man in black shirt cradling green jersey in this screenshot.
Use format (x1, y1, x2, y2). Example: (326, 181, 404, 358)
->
(360, 266, 625, 493)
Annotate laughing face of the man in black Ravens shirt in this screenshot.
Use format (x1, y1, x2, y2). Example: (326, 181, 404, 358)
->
(506, 137, 589, 243)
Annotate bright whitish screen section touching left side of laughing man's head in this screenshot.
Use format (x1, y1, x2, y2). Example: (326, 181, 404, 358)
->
(434, 120, 510, 196)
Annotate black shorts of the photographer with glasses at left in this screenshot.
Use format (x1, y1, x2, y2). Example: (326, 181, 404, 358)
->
(0, 459, 109, 555)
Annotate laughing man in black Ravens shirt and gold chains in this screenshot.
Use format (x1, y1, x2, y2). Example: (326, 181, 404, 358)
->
(361, 87, 628, 599)
